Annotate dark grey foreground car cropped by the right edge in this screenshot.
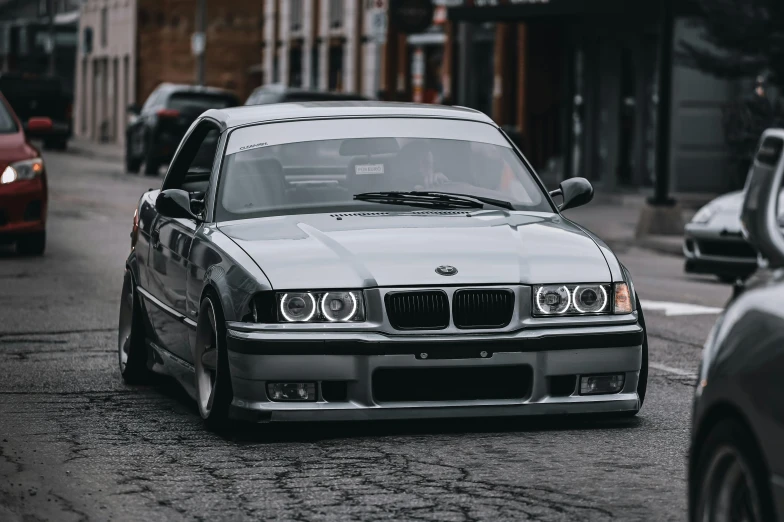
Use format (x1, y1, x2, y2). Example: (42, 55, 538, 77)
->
(689, 130, 784, 522)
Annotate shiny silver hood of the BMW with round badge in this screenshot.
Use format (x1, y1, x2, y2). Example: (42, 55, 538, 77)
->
(219, 211, 611, 290)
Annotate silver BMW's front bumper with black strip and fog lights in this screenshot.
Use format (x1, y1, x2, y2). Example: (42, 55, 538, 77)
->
(228, 324, 644, 422)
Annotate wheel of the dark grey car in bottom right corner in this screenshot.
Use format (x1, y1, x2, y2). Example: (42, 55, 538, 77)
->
(691, 418, 775, 522)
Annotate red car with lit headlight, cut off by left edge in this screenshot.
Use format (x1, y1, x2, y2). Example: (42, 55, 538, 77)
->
(0, 94, 52, 255)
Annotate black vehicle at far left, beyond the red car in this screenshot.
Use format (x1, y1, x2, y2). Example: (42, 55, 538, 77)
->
(0, 73, 73, 150)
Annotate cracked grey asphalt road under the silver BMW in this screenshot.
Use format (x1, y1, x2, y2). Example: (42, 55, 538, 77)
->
(0, 148, 730, 521)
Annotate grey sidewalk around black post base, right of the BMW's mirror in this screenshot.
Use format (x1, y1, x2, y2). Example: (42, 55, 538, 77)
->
(564, 194, 692, 256)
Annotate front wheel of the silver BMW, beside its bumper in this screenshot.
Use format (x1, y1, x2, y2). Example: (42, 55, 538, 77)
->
(193, 292, 233, 431)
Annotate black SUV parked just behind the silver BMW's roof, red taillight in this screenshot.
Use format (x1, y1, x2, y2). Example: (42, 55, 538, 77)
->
(125, 83, 240, 175)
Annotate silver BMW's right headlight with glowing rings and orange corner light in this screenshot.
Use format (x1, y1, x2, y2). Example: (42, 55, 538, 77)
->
(533, 283, 632, 317)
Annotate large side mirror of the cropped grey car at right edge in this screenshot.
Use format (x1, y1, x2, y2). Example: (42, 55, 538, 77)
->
(741, 129, 784, 268)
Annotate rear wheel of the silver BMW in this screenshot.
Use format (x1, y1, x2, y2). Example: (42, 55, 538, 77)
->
(117, 269, 151, 384)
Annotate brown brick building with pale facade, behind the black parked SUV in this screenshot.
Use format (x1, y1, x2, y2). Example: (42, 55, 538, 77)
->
(75, 0, 264, 143)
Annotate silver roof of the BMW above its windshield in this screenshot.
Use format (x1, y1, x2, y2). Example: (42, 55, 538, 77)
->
(202, 101, 495, 128)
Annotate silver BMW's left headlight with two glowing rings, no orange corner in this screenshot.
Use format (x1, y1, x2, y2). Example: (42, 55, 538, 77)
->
(275, 290, 365, 323)
